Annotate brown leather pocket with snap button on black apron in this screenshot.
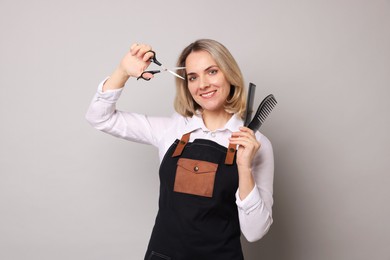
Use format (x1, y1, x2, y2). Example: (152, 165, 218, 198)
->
(173, 158, 218, 198)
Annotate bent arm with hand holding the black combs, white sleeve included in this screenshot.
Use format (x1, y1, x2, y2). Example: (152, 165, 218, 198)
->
(232, 128, 274, 242)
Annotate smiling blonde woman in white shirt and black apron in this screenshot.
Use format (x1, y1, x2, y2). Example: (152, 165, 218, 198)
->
(86, 39, 274, 260)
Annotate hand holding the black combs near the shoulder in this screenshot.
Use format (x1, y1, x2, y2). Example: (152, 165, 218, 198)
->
(229, 127, 261, 169)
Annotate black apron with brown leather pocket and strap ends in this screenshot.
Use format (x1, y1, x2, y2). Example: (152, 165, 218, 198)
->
(145, 134, 244, 260)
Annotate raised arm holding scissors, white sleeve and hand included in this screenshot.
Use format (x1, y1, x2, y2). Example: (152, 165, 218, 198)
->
(86, 45, 170, 145)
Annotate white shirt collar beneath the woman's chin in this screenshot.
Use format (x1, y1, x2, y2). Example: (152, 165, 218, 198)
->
(185, 113, 244, 133)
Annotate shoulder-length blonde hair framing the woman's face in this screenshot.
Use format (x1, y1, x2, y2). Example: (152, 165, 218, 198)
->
(174, 39, 246, 118)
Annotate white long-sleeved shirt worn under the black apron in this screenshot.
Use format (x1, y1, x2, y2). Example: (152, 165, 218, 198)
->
(86, 81, 274, 241)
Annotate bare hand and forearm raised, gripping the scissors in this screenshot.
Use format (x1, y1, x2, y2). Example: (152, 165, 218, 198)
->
(102, 43, 153, 92)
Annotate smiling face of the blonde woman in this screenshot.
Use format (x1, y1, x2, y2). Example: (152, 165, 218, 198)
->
(185, 51, 231, 113)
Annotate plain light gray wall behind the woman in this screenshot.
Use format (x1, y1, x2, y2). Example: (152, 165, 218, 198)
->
(0, 0, 390, 260)
